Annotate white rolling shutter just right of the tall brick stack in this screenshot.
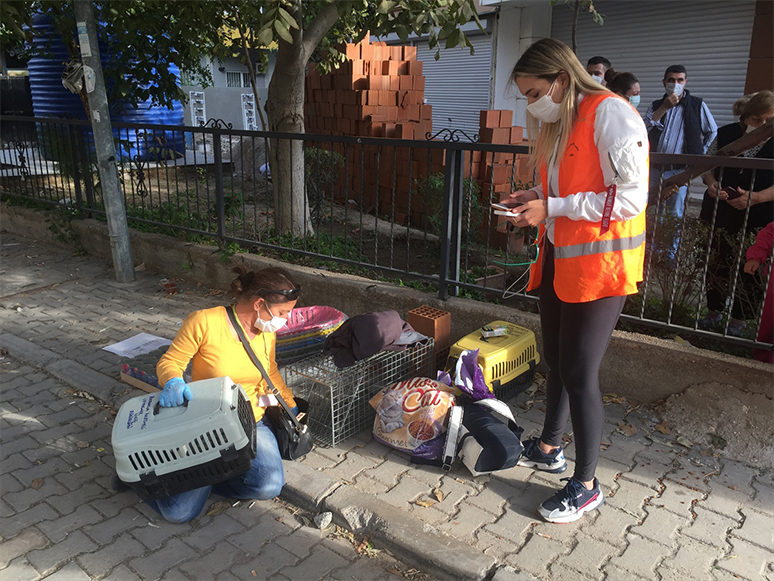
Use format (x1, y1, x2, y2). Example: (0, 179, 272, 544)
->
(415, 34, 492, 137)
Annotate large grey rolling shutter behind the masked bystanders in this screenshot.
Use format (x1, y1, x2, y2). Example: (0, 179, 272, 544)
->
(551, 0, 755, 126)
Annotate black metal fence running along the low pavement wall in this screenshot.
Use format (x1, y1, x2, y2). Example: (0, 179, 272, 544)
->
(0, 116, 771, 349)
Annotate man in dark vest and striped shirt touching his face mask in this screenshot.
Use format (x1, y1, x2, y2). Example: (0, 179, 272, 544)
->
(643, 65, 718, 218)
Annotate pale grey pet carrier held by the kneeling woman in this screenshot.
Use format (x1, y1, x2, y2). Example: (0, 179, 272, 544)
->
(112, 377, 256, 500)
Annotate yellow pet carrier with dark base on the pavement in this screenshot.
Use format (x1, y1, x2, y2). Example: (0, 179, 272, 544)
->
(446, 321, 540, 400)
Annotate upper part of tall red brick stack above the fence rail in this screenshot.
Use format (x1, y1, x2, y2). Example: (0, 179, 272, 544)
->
(304, 35, 433, 139)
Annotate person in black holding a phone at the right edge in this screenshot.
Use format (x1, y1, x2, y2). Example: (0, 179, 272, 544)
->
(699, 91, 774, 337)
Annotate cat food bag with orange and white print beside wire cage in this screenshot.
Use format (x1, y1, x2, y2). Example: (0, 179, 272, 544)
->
(369, 377, 455, 454)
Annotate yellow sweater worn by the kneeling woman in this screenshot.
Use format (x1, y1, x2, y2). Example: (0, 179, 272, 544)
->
(156, 307, 296, 421)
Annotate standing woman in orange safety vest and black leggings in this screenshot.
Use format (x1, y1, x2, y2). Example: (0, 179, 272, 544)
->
(503, 38, 648, 523)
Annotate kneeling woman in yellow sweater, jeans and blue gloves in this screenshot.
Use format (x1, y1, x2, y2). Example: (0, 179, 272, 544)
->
(113, 265, 300, 523)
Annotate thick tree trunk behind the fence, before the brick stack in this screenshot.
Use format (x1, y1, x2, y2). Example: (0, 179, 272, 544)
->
(266, 0, 314, 236)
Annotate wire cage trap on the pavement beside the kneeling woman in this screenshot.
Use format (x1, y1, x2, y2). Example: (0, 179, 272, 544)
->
(283, 339, 436, 447)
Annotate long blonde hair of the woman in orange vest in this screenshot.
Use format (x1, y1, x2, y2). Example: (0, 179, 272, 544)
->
(511, 38, 613, 167)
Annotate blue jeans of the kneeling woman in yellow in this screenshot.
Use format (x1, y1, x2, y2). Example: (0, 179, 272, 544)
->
(146, 420, 285, 523)
